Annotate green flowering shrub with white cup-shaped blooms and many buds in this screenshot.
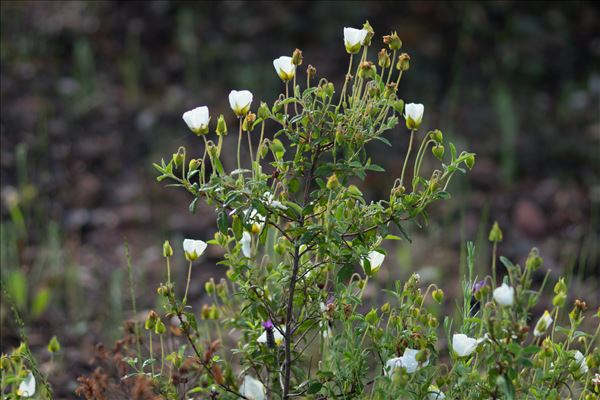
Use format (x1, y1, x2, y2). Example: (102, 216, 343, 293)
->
(72, 23, 600, 400)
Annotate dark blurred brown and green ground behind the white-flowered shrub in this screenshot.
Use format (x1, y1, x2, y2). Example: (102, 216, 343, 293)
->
(0, 1, 600, 398)
